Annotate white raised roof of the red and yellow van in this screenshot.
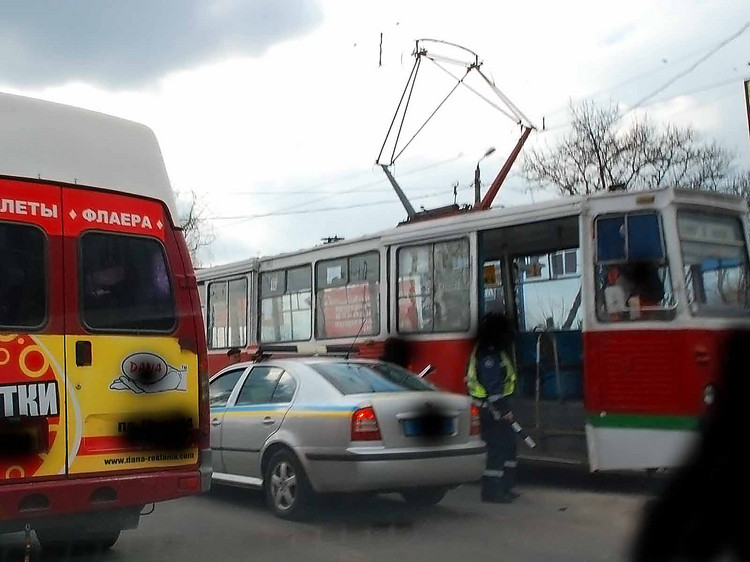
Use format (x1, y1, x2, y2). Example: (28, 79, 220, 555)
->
(0, 93, 177, 219)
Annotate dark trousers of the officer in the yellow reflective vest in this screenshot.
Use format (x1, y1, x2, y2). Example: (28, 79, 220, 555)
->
(480, 408, 518, 499)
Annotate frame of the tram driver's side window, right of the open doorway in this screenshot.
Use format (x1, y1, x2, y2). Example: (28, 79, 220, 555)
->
(593, 209, 677, 324)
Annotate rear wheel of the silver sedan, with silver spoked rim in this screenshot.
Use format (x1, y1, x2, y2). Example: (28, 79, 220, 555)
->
(263, 451, 314, 519)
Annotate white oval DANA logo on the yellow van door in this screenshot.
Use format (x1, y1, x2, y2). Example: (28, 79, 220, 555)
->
(109, 352, 187, 394)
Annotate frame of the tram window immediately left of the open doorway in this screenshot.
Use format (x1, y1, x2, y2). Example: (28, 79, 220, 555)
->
(395, 237, 472, 335)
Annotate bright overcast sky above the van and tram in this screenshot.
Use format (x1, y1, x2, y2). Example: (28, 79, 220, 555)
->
(0, 0, 750, 264)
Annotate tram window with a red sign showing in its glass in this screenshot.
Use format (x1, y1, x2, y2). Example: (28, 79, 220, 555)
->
(315, 252, 380, 339)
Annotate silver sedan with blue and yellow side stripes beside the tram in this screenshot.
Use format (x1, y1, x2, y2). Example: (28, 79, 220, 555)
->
(210, 357, 486, 518)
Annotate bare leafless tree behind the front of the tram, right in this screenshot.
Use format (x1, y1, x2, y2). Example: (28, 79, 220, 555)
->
(523, 102, 734, 195)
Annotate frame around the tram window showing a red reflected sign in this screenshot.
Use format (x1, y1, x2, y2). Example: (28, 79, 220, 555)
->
(315, 251, 382, 340)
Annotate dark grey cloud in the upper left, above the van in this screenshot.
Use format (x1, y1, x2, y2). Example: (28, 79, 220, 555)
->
(0, 0, 322, 88)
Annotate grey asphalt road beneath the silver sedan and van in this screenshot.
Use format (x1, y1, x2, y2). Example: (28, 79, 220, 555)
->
(0, 472, 653, 562)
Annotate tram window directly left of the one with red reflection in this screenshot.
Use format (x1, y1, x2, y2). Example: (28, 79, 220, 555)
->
(260, 266, 312, 343)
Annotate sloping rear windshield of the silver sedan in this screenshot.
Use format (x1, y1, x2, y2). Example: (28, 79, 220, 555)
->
(310, 361, 434, 394)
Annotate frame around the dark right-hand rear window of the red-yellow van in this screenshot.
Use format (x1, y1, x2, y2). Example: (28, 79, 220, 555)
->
(77, 230, 179, 334)
